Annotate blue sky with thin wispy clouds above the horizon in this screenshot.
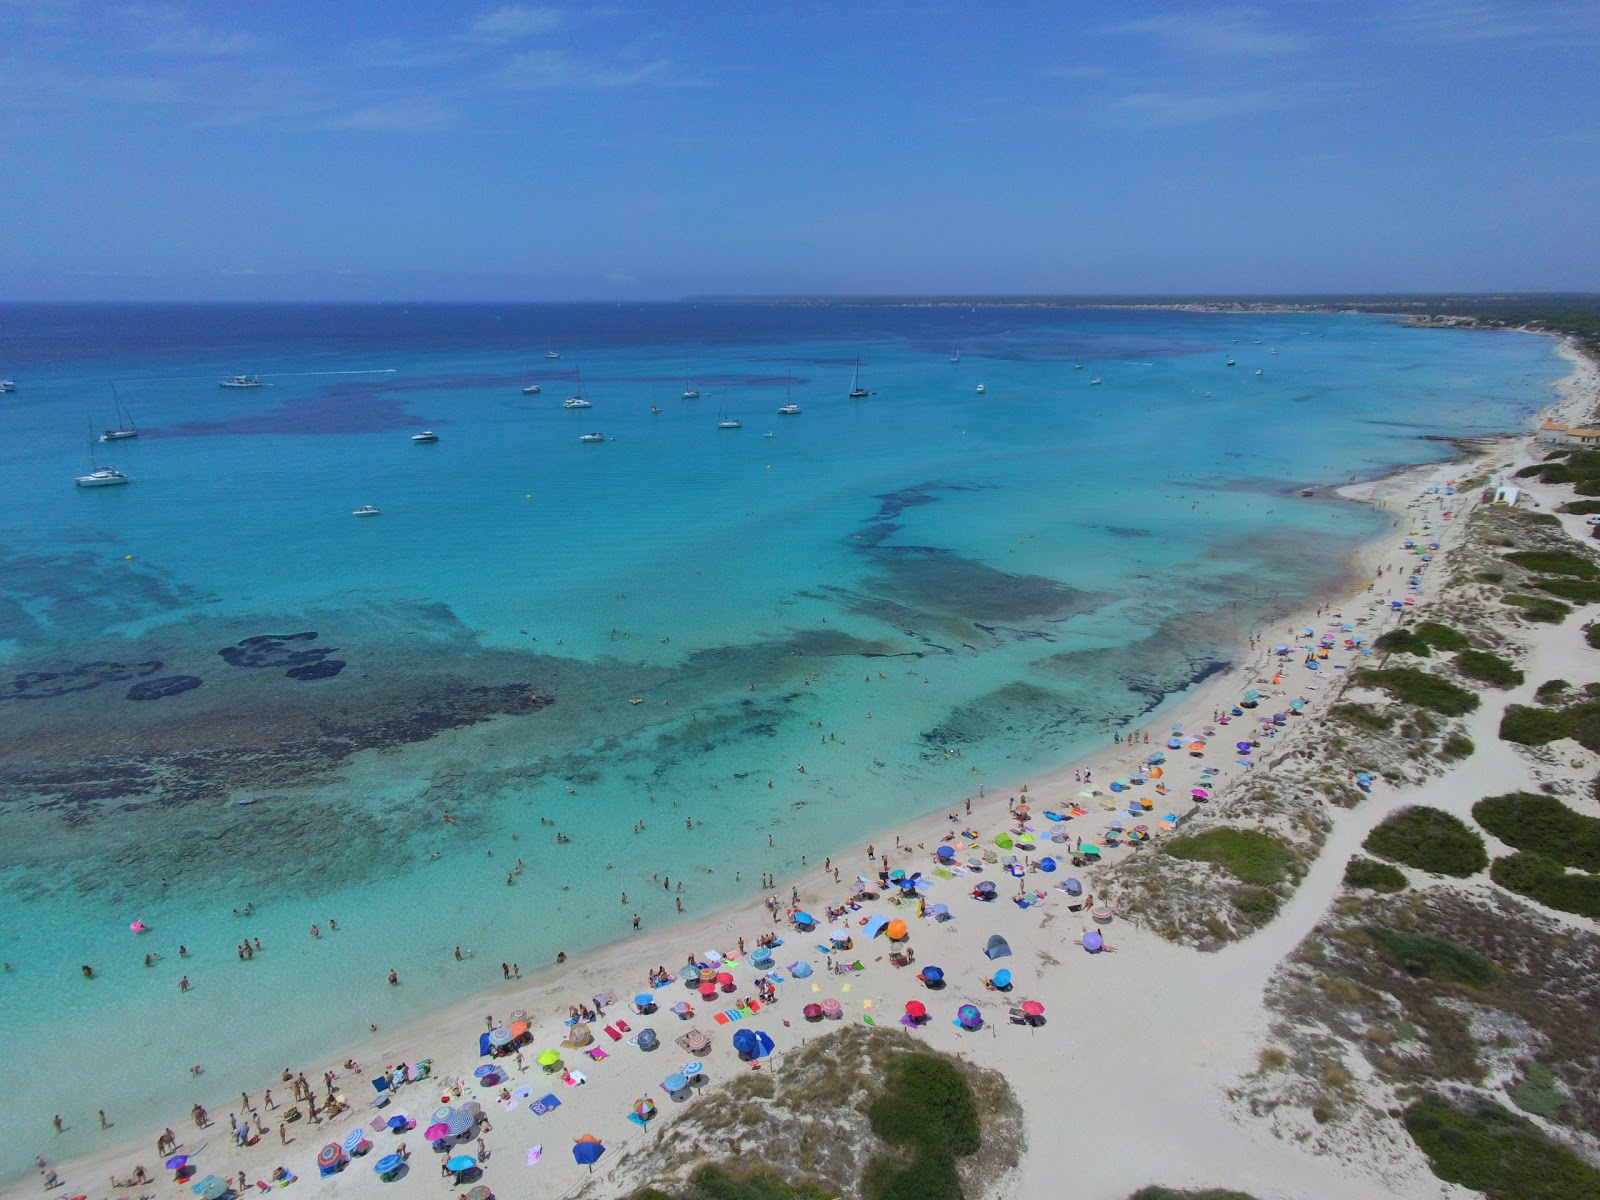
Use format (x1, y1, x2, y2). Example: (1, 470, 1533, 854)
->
(0, 0, 1600, 299)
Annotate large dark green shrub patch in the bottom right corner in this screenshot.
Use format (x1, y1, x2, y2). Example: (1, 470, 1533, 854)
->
(1403, 1096, 1600, 1200)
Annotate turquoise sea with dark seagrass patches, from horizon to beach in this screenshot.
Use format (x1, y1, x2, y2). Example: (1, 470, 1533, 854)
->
(0, 304, 1565, 1176)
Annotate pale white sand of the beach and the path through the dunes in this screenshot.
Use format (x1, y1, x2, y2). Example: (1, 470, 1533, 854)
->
(21, 339, 1600, 1200)
